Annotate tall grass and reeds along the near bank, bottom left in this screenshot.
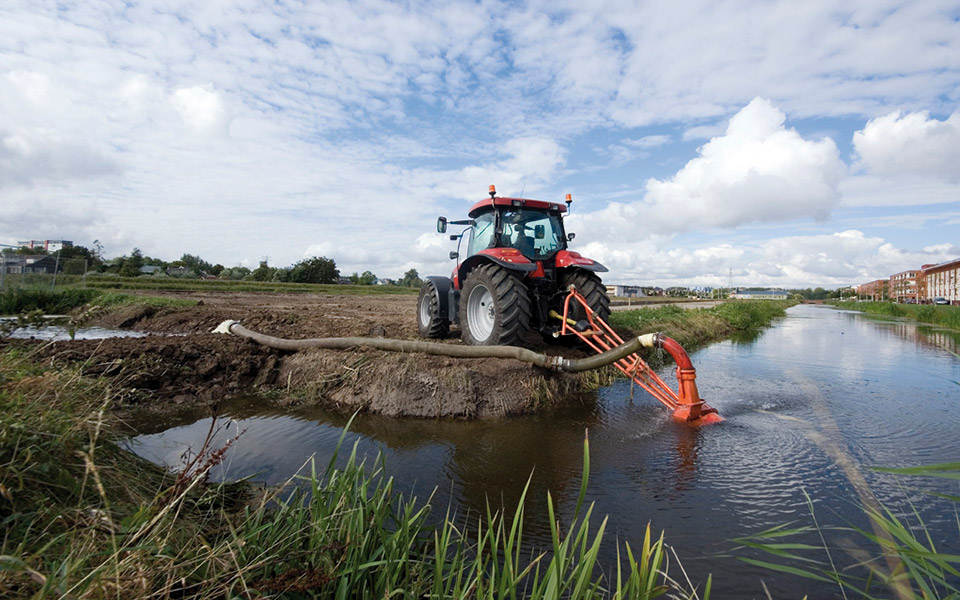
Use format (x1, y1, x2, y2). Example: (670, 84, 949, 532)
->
(0, 345, 696, 599)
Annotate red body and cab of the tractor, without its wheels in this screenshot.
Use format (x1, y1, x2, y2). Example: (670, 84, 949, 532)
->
(434, 185, 607, 336)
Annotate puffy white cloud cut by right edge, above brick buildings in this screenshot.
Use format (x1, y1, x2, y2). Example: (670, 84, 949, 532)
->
(853, 111, 960, 180)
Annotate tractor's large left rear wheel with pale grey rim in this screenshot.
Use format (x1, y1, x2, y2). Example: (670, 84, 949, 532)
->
(460, 264, 530, 346)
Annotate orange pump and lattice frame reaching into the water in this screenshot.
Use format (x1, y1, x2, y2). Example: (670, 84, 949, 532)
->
(552, 285, 723, 426)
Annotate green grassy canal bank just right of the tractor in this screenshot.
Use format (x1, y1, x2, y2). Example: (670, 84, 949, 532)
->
(610, 300, 796, 351)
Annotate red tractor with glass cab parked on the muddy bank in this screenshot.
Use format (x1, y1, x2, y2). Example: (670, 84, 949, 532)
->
(417, 185, 610, 346)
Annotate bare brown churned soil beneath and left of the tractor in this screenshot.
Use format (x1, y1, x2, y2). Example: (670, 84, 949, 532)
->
(16, 292, 595, 418)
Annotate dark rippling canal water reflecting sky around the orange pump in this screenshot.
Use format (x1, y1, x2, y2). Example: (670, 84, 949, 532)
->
(132, 306, 960, 598)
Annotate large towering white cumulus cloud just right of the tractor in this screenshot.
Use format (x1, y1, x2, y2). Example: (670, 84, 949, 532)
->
(572, 98, 845, 245)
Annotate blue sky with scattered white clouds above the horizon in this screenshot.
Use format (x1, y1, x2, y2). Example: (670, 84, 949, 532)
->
(0, 0, 960, 287)
